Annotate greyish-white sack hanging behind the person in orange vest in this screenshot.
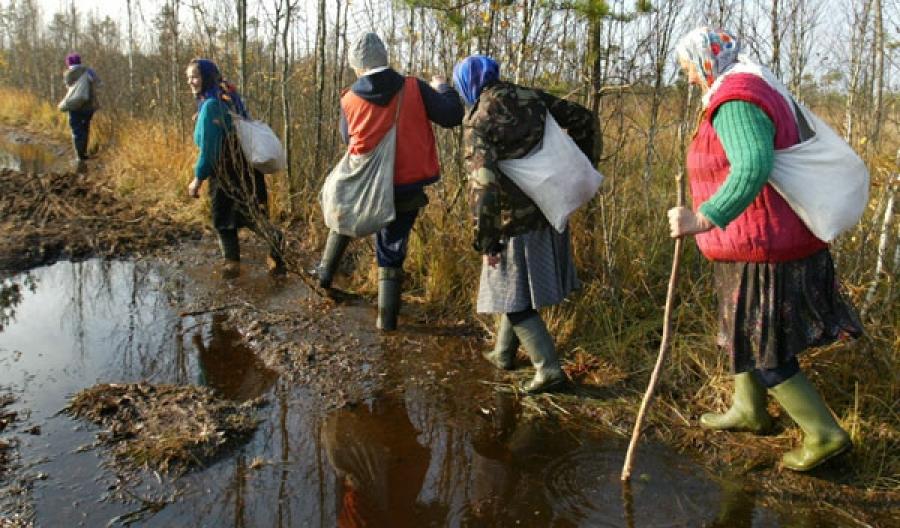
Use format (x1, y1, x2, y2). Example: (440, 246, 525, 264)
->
(319, 125, 397, 237)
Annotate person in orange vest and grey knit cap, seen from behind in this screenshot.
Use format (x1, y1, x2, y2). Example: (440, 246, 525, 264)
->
(315, 33, 463, 330)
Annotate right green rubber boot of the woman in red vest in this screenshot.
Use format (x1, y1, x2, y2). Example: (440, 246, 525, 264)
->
(769, 372, 852, 471)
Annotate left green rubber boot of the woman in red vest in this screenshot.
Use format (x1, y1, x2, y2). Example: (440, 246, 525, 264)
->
(700, 372, 772, 434)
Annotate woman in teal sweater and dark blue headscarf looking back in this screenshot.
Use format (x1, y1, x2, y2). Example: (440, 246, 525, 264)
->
(186, 59, 284, 277)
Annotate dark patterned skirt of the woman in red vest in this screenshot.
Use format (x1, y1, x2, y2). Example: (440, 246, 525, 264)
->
(713, 249, 863, 374)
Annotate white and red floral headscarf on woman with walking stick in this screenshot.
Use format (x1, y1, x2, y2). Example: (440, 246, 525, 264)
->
(675, 26, 741, 88)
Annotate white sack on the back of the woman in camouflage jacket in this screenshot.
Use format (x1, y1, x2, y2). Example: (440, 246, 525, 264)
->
(498, 112, 603, 233)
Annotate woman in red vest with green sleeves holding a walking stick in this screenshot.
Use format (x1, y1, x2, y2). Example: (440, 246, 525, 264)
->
(669, 28, 862, 471)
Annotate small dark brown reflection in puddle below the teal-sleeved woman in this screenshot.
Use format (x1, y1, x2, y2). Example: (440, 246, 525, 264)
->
(191, 314, 277, 401)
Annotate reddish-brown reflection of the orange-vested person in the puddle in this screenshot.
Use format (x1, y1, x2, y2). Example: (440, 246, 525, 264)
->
(321, 399, 429, 528)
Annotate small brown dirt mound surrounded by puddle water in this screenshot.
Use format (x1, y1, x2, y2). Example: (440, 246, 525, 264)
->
(66, 383, 264, 473)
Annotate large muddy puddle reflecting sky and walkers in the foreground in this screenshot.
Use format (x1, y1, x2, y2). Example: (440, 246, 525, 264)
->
(0, 261, 872, 527)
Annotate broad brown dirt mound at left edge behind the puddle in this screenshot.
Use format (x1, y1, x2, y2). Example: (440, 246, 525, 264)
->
(0, 170, 194, 271)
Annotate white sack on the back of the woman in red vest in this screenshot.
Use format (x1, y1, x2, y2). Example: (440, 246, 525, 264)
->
(769, 101, 869, 242)
